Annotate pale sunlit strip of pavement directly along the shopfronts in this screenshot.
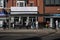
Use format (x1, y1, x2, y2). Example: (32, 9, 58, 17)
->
(0, 28, 55, 33)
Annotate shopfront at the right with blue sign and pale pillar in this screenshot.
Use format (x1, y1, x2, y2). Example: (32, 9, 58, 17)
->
(45, 14, 60, 28)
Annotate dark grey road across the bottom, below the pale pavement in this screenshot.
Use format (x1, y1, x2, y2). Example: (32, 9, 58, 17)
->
(0, 32, 60, 40)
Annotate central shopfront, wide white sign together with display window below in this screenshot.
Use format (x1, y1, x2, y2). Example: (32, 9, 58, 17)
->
(10, 7, 38, 29)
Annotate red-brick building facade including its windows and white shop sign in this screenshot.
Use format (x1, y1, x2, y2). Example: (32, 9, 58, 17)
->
(0, 0, 60, 27)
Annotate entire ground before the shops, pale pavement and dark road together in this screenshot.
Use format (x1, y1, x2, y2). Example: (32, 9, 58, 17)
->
(0, 29, 60, 40)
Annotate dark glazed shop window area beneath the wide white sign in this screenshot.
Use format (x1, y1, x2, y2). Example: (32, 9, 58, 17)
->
(11, 16, 37, 29)
